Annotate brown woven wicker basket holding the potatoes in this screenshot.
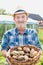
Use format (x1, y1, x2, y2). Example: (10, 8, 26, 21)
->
(8, 45, 41, 65)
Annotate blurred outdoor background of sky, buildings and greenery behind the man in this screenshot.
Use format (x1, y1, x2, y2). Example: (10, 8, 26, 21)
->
(0, 0, 43, 65)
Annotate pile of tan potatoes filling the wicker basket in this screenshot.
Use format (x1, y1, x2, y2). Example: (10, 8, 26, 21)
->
(10, 46, 38, 61)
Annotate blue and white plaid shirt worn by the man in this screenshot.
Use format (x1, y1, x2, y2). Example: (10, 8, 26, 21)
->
(2, 28, 41, 50)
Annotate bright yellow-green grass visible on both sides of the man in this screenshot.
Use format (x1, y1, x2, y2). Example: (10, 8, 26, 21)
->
(0, 29, 43, 65)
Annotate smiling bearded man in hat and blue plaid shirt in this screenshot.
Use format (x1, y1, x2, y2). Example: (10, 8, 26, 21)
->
(2, 9, 41, 64)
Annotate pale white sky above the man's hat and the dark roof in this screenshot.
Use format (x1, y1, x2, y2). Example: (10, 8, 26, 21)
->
(0, 0, 43, 17)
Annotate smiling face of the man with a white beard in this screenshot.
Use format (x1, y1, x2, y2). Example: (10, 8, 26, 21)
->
(14, 13, 28, 29)
